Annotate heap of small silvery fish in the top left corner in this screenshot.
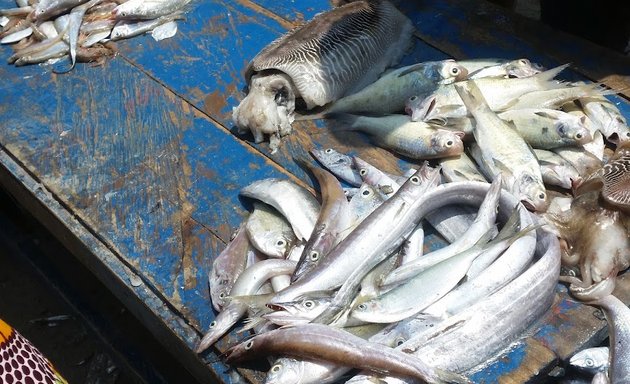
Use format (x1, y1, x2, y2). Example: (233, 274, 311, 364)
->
(0, 0, 190, 69)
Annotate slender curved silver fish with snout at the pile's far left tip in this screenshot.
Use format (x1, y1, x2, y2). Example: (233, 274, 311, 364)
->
(195, 259, 296, 353)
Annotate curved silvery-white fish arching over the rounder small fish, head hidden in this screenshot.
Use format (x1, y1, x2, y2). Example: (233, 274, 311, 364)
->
(240, 178, 320, 241)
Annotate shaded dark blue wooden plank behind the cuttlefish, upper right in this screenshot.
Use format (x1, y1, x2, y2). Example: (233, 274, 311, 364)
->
(400, 0, 630, 97)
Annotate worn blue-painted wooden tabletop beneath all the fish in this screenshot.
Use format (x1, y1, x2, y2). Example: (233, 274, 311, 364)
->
(0, 0, 630, 383)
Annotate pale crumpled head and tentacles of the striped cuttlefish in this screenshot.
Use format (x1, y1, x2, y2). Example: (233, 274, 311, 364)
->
(232, 73, 295, 147)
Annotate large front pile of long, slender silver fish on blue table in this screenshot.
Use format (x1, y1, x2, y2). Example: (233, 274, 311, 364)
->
(197, 149, 560, 383)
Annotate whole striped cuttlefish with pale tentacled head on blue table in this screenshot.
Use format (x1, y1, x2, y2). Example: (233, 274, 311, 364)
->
(232, 0, 414, 153)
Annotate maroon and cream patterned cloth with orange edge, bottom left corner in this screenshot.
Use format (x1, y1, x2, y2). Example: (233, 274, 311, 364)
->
(0, 319, 67, 384)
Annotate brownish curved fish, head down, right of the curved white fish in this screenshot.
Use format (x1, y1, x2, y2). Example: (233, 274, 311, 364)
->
(291, 163, 351, 282)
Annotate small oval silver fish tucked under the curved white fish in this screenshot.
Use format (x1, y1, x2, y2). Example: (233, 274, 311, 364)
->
(245, 201, 297, 258)
